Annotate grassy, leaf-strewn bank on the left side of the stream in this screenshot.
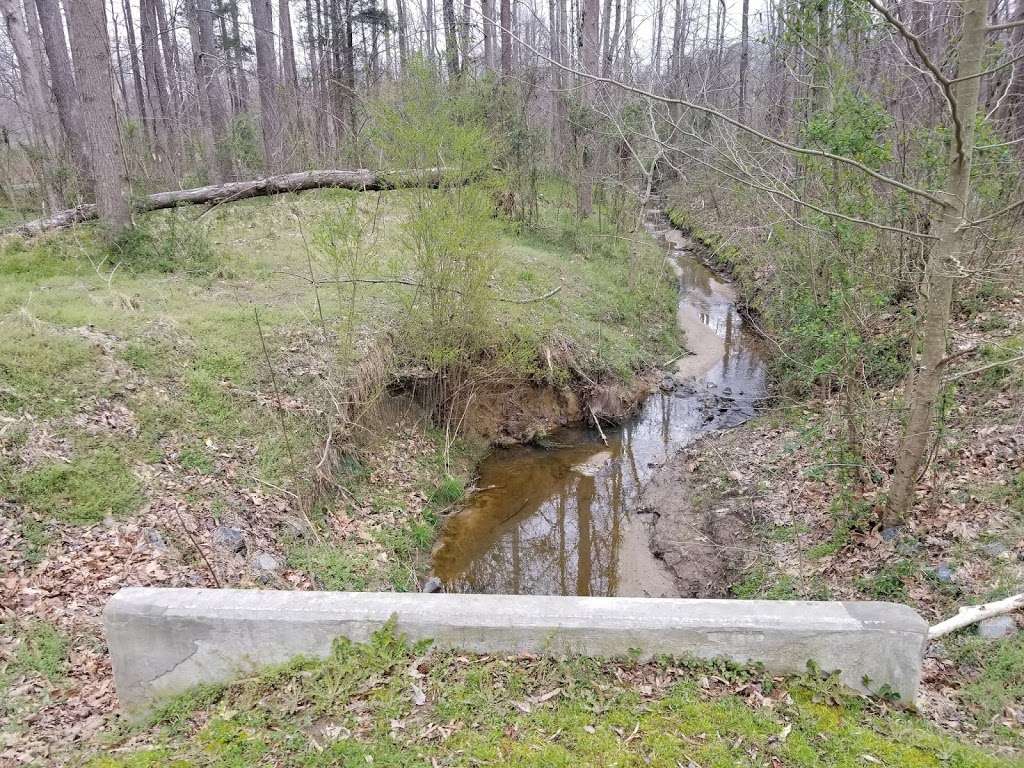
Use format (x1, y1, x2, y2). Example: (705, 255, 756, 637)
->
(0, 183, 678, 759)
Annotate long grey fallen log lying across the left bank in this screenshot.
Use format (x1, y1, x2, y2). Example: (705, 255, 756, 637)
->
(10, 168, 441, 237)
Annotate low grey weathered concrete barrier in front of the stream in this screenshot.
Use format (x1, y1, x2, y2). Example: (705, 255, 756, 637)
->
(103, 588, 928, 712)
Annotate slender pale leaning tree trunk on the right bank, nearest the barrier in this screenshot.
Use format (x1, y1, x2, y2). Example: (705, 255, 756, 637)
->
(882, 0, 988, 527)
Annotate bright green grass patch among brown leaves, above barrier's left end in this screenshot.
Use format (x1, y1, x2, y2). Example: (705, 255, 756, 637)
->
(15, 446, 141, 524)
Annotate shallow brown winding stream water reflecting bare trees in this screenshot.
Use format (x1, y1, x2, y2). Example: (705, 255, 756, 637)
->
(433, 214, 764, 596)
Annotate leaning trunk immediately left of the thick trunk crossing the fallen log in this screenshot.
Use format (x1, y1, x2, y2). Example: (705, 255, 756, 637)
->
(30, 0, 92, 188)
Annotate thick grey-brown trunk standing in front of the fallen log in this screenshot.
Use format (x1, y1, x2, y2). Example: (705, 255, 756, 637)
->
(68, 0, 132, 237)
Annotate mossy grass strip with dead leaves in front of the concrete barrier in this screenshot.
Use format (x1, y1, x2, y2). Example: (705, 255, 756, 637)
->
(86, 629, 1011, 768)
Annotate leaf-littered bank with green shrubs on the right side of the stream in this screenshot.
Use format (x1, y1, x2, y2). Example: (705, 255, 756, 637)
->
(659, 180, 1024, 755)
